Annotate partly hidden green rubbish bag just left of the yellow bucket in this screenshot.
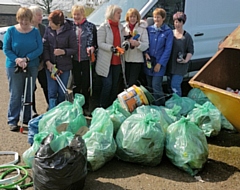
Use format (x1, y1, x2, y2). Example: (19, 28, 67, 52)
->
(106, 99, 131, 135)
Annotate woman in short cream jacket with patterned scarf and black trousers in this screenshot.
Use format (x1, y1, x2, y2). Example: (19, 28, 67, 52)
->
(124, 8, 149, 86)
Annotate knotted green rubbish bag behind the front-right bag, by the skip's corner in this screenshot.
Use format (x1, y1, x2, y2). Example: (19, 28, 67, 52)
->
(187, 101, 221, 137)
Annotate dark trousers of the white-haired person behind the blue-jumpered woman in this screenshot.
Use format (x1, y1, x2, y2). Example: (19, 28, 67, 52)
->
(32, 69, 49, 113)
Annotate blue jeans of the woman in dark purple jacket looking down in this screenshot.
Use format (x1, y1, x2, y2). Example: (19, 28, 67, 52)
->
(46, 69, 70, 104)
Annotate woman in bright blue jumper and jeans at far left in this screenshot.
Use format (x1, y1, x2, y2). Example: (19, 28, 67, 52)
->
(3, 7, 43, 131)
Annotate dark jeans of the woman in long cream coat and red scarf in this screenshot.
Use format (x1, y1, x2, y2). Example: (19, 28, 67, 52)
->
(100, 65, 122, 108)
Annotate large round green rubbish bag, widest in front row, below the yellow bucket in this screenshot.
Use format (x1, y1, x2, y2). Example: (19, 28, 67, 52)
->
(116, 110, 165, 166)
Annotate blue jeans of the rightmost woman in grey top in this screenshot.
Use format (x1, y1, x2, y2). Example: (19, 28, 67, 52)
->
(167, 74, 183, 97)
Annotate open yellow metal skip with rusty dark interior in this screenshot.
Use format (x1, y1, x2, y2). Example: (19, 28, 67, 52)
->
(189, 26, 240, 131)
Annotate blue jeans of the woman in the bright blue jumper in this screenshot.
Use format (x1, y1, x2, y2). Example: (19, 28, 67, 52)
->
(6, 67, 38, 125)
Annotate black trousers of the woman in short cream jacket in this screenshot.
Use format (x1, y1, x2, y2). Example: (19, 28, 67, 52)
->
(125, 62, 143, 86)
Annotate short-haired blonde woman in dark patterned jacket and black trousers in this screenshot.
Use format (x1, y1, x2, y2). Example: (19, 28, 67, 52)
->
(72, 5, 97, 115)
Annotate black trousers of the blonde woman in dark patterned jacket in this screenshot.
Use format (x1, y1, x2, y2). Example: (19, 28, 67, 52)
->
(72, 60, 90, 109)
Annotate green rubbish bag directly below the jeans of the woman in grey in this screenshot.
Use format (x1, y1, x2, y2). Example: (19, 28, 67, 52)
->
(165, 93, 196, 116)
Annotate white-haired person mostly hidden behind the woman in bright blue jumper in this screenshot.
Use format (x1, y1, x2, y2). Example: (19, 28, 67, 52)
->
(29, 6, 48, 113)
